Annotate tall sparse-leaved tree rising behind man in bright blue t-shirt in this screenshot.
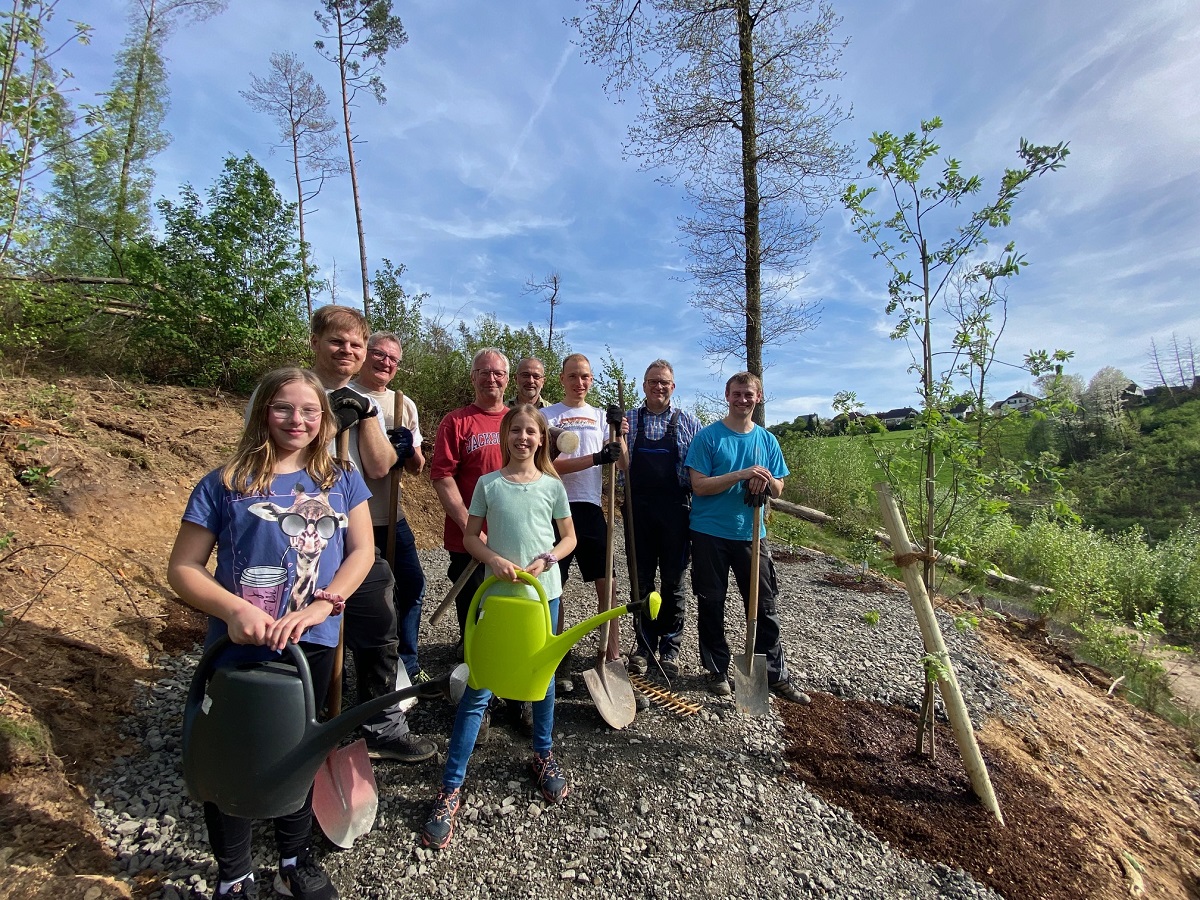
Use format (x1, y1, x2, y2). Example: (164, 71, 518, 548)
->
(571, 0, 852, 424)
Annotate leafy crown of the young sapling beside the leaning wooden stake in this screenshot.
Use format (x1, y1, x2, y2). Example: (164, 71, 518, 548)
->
(842, 118, 1070, 589)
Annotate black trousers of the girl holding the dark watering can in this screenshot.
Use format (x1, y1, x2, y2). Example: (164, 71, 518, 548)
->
(204, 643, 334, 893)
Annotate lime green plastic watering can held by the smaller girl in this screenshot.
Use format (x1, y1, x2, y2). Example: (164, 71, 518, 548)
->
(463, 572, 662, 701)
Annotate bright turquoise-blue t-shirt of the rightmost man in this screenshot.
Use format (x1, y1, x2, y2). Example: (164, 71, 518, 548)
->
(685, 422, 788, 541)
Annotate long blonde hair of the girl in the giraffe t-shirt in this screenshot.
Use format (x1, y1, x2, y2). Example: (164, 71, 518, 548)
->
(221, 366, 349, 496)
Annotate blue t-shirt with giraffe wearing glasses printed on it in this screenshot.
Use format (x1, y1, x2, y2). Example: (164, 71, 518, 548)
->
(184, 469, 371, 647)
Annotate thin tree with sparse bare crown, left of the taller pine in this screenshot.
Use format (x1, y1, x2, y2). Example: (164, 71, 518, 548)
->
(240, 53, 347, 319)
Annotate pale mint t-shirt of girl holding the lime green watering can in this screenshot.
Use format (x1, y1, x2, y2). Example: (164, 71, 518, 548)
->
(467, 472, 571, 600)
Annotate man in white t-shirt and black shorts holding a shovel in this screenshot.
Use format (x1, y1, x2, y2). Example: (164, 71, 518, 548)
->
(541, 353, 628, 688)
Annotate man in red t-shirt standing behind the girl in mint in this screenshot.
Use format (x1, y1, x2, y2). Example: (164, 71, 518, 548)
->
(430, 347, 509, 642)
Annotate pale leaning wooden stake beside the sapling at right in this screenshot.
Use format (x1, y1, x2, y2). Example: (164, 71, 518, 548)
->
(875, 482, 1004, 824)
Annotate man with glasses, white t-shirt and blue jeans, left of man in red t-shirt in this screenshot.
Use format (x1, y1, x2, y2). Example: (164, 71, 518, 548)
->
(352, 331, 430, 684)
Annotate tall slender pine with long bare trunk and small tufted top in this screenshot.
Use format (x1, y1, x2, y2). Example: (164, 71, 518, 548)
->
(313, 0, 408, 317)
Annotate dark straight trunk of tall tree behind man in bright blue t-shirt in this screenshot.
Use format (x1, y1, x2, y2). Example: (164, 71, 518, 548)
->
(738, 0, 767, 425)
